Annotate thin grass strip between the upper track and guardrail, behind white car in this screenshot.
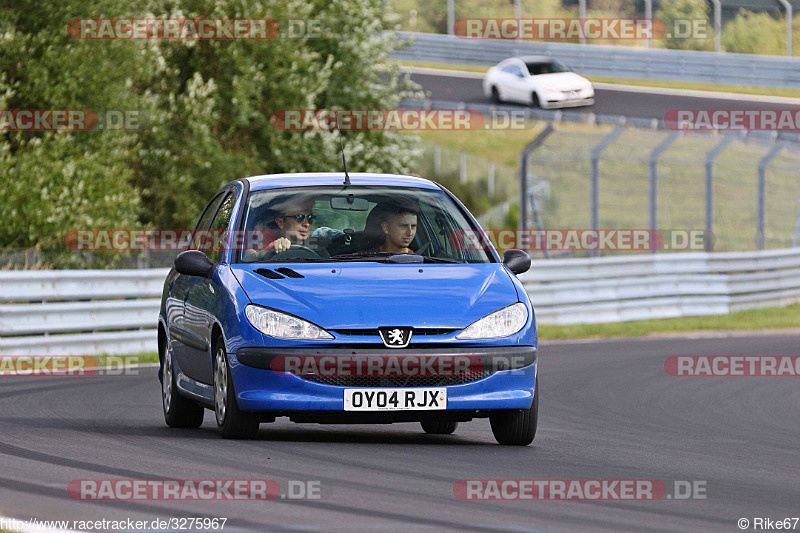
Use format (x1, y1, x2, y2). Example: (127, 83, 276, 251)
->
(399, 59, 800, 98)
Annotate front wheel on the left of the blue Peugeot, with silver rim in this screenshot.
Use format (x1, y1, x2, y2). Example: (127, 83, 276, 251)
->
(214, 336, 259, 439)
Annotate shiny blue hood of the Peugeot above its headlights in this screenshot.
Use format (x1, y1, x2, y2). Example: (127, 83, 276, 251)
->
(231, 262, 519, 329)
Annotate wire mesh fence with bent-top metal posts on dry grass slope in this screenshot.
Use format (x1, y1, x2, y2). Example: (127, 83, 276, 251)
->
(519, 119, 800, 255)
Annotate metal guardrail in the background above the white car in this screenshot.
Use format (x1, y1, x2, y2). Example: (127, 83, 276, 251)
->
(391, 32, 800, 87)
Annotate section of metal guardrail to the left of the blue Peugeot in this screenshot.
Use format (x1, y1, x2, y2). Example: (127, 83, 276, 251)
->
(0, 268, 169, 355)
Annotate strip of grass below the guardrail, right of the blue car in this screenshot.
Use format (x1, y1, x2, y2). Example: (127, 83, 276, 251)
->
(539, 304, 800, 341)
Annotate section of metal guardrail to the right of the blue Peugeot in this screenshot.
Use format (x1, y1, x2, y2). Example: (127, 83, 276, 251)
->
(520, 248, 800, 325)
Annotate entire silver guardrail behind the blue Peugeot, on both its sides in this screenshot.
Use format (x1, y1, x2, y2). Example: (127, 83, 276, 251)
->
(0, 248, 800, 355)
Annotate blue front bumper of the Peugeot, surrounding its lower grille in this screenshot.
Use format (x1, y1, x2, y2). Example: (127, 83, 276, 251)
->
(228, 346, 537, 412)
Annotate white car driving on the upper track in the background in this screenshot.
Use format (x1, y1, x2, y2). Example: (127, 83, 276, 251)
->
(483, 56, 594, 109)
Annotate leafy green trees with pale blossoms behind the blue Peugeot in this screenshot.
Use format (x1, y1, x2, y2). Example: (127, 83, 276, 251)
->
(0, 0, 416, 266)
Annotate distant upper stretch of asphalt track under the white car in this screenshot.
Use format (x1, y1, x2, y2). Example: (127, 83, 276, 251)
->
(411, 73, 800, 119)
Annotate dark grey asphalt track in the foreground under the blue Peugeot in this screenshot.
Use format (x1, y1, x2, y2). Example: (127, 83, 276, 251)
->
(0, 335, 800, 532)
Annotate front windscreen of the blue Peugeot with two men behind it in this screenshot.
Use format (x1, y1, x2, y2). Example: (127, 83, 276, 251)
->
(238, 185, 495, 263)
